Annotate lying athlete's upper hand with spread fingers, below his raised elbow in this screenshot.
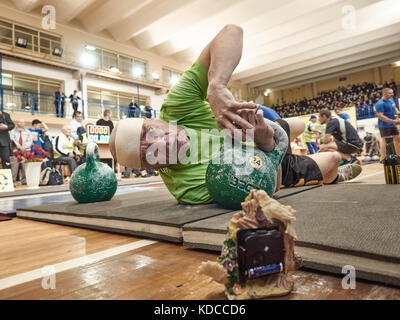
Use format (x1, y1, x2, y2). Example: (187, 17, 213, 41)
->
(207, 84, 258, 133)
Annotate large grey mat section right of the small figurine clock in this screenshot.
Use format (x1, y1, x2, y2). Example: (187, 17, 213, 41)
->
(279, 184, 400, 263)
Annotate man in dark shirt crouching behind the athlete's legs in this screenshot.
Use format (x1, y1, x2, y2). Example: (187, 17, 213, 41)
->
(319, 110, 363, 163)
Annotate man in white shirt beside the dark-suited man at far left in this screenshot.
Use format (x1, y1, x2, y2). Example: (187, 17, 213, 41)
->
(10, 119, 33, 184)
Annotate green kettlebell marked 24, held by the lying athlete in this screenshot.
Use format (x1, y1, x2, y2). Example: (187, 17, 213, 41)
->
(206, 119, 289, 210)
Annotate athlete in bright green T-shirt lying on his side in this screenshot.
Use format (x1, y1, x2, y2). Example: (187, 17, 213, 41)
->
(110, 25, 361, 204)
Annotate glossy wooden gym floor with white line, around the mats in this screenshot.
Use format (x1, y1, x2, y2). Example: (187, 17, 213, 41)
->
(0, 163, 400, 300)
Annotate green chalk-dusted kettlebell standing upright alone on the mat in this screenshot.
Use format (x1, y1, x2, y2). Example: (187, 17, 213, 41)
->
(69, 142, 118, 203)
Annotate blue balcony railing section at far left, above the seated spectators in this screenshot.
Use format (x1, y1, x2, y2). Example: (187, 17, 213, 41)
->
(0, 87, 85, 116)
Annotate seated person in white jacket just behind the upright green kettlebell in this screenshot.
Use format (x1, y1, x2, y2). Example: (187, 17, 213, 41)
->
(54, 125, 80, 173)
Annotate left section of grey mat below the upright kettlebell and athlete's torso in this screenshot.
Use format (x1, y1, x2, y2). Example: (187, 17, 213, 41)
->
(17, 187, 230, 242)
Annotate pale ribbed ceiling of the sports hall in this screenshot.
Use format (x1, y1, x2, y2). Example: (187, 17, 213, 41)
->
(1, 0, 400, 89)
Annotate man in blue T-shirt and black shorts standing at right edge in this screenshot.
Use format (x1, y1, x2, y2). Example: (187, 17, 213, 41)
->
(375, 88, 400, 161)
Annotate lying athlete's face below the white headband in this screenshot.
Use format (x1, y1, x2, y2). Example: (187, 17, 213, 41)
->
(140, 119, 189, 169)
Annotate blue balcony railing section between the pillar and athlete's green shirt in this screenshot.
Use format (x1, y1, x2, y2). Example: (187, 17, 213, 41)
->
(87, 99, 159, 120)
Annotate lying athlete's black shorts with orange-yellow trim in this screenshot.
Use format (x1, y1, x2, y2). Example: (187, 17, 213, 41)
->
(275, 119, 324, 187)
